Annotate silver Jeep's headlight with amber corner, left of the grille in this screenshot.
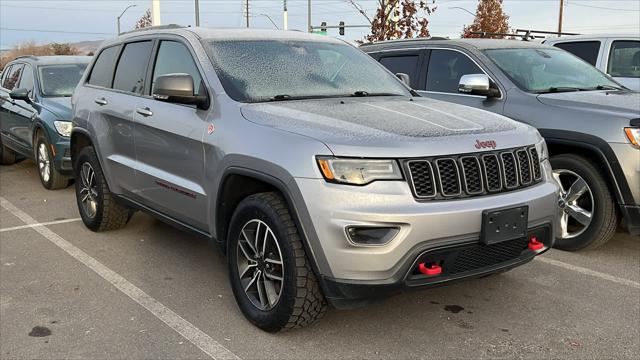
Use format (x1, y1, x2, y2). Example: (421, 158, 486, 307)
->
(317, 157, 402, 185)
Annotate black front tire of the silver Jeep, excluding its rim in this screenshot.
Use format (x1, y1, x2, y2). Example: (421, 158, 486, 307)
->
(227, 193, 327, 332)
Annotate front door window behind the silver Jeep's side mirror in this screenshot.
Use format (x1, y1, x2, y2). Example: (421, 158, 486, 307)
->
(151, 40, 204, 94)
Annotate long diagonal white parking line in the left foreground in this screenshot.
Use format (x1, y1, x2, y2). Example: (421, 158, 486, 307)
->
(0, 196, 239, 359)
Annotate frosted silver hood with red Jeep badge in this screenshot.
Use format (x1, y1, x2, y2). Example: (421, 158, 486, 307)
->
(241, 96, 539, 157)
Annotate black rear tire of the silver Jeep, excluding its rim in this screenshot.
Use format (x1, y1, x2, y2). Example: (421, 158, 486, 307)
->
(74, 146, 133, 232)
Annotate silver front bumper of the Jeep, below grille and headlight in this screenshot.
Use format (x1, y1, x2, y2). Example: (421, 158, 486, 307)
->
(295, 162, 558, 304)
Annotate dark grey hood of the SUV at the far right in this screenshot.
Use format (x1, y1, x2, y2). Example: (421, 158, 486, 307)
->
(538, 90, 640, 119)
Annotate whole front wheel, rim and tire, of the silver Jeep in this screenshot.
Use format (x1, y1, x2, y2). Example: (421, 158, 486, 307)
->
(227, 193, 327, 332)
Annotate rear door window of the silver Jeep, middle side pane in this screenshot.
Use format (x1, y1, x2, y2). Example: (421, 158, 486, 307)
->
(113, 41, 152, 94)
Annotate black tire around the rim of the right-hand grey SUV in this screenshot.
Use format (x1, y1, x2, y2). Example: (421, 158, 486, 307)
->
(551, 154, 619, 251)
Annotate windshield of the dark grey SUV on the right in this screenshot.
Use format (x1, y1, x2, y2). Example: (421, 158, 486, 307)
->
(484, 48, 621, 93)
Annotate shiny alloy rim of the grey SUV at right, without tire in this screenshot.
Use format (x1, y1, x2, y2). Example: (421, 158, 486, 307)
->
(553, 169, 594, 239)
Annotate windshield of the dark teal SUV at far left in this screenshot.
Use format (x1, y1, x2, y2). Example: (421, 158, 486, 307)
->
(38, 64, 87, 97)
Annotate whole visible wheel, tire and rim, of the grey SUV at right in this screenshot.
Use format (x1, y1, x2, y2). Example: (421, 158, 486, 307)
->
(551, 154, 619, 251)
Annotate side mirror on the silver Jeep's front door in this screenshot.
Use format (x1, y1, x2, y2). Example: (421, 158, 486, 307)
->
(152, 73, 209, 109)
